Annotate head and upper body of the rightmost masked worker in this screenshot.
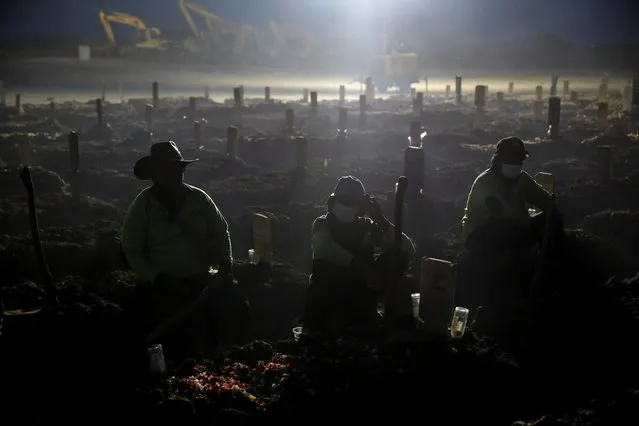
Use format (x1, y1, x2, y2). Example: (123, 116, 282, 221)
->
(462, 137, 563, 261)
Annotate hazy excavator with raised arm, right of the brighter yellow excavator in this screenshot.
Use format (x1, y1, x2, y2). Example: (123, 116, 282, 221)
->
(178, 0, 258, 60)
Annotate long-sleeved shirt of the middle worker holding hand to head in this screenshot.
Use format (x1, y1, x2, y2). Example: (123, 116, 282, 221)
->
(311, 216, 415, 266)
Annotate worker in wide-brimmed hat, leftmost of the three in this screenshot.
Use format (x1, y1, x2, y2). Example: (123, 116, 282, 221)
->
(121, 141, 248, 350)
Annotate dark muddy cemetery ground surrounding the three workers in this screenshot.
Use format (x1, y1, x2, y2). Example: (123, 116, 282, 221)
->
(0, 84, 639, 425)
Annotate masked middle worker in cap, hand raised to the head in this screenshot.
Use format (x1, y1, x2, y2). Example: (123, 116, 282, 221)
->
(304, 176, 415, 334)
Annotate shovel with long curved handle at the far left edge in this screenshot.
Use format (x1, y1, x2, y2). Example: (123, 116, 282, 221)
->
(2, 167, 58, 316)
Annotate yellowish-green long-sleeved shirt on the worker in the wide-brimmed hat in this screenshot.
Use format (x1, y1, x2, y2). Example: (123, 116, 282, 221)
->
(122, 184, 233, 282)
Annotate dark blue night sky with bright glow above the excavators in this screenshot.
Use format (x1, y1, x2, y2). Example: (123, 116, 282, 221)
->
(0, 0, 639, 44)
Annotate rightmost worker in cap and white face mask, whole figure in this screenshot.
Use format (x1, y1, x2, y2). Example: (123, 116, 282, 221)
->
(460, 137, 564, 306)
